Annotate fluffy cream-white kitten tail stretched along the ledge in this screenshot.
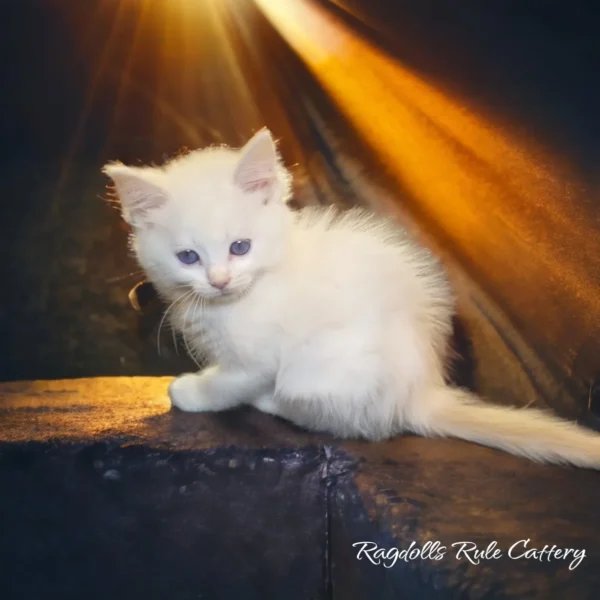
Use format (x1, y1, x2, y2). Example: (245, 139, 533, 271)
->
(407, 387, 600, 469)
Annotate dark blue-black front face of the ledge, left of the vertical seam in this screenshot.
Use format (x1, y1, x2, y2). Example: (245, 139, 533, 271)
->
(0, 444, 327, 600)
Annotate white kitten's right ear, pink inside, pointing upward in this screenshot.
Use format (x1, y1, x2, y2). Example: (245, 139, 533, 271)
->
(233, 129, 279, 197)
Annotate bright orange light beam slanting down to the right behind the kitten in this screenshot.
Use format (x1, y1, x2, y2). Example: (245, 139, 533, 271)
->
(256, 0, 600, 352)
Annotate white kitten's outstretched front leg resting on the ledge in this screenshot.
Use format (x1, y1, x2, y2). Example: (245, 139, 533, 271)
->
(169, 366, 265, 412)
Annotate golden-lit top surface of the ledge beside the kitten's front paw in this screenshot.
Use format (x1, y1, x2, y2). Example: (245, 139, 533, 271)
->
(0, 377, 330, 449)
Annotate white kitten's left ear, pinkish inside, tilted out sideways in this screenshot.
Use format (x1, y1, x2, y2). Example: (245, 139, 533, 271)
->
(102, 163, 167, 227)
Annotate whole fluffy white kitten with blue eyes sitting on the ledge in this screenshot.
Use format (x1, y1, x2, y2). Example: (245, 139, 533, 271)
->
(104, 130, 600, 468)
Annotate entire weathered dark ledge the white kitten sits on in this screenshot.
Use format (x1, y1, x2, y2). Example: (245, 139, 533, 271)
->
(0, 378, 600, 600)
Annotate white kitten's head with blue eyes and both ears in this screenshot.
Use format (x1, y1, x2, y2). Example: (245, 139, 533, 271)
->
(103, 129, 290, 297)
